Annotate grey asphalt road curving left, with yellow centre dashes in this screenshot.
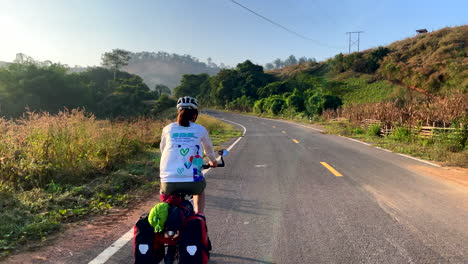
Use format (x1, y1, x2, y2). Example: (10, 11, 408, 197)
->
(103, 112, 468, 263)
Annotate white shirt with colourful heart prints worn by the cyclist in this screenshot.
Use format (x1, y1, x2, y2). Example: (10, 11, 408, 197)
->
(159, 122, 216, 182)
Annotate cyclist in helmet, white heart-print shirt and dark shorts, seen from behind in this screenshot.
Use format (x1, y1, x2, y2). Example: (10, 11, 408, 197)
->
(160, 96, 218, 214)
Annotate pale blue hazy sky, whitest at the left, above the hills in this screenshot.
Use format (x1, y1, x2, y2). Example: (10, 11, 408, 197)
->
(0, 0, 468, 66)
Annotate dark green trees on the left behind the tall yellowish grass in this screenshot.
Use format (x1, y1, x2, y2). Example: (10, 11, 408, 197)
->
(0, 60, 176, 117)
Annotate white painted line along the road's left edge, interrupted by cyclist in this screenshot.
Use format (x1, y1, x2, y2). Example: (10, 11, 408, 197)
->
(88, 118, 247, 264)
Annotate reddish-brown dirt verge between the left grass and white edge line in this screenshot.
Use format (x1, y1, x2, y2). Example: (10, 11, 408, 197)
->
(2, 190, 159, 264)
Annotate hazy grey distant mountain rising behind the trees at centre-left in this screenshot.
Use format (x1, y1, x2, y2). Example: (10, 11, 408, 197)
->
(123, 52, 221, 89)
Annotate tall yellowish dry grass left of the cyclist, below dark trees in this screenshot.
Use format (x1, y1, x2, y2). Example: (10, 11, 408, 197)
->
(0, 110, 164, 189)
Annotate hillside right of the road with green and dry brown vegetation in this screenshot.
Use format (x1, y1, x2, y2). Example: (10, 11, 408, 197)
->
(269, 25, 468, 105)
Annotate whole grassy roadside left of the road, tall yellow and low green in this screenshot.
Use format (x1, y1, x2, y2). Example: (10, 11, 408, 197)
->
(0, 111, 240, 257)
